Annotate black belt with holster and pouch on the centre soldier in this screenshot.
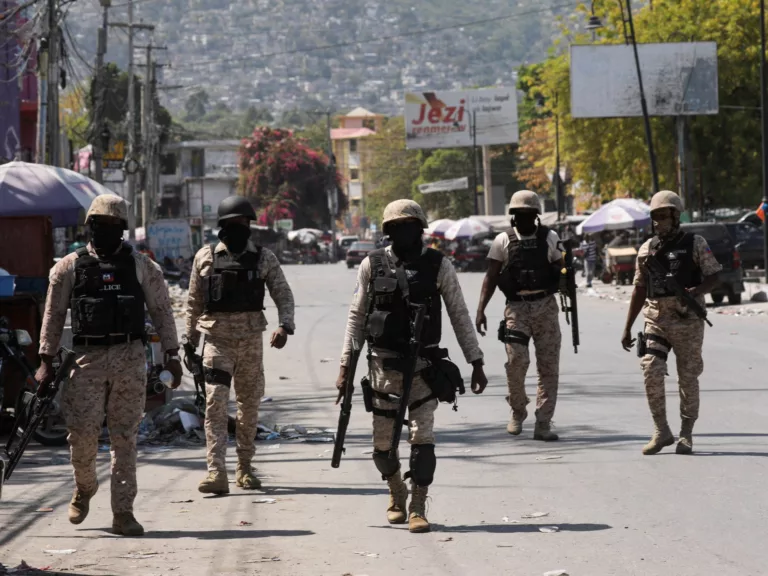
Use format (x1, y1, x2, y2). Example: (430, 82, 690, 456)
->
(360, 347, 466, 419)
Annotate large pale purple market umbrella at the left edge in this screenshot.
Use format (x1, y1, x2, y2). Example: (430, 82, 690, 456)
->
(0, 162, 121, 228)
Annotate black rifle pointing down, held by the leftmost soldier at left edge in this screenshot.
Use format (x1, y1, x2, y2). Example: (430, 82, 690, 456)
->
(0, 348, 75, 497)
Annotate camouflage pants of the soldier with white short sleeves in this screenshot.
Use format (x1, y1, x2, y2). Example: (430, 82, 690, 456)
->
(504, 297, 561, 422)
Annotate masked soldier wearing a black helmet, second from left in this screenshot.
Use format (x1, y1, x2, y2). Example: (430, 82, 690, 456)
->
(187, 196, 294, 494)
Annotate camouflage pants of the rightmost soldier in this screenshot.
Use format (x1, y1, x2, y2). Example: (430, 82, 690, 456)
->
(640, 319, 704, 424)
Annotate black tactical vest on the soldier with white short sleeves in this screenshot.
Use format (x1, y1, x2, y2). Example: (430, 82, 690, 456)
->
(498, 225, 560, 300)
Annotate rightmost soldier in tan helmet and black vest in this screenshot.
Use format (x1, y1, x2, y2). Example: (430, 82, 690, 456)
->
(621, 190, 722, 454)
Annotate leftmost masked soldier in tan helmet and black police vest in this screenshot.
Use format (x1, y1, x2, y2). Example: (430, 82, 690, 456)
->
(36, 194, 182, 536)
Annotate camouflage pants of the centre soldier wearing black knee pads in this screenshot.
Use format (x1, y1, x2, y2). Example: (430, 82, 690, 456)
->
(371, 358, 437, 450)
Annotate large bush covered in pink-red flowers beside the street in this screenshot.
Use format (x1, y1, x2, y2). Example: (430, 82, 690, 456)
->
(234, 126, 347, 229)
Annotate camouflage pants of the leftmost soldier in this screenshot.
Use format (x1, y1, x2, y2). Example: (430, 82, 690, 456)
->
(62, 341, 147, 514)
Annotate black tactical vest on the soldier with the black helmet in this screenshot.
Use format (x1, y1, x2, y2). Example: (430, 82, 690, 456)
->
(202, 248, 265, 313)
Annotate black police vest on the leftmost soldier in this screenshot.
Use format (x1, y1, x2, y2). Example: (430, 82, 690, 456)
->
(70, 244, 144, 340)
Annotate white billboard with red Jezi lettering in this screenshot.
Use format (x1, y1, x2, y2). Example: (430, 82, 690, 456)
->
(405, 88, 519, 150)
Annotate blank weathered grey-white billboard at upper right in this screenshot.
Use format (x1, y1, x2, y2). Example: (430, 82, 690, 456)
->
(571, 42, 719, 118)
